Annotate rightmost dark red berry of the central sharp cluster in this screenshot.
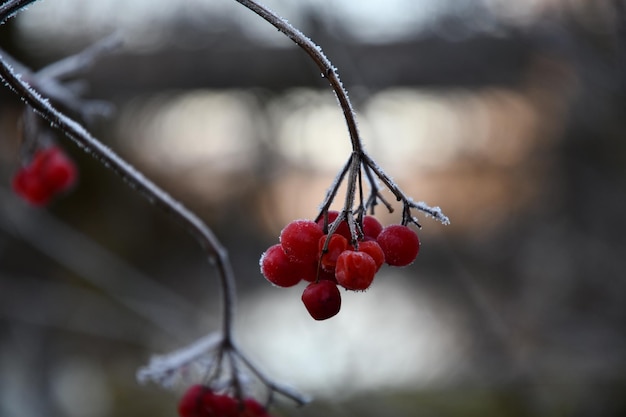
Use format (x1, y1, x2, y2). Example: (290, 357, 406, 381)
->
(376, 224, 420, 266)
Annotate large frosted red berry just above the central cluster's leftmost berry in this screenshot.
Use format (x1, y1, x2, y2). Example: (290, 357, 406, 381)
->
(280, 220, 324, 263)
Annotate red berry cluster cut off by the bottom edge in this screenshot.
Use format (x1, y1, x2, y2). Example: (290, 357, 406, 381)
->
(178, 384, 271, 417)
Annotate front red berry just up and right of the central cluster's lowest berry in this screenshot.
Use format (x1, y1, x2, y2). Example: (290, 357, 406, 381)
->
(335, 250, 376, 290)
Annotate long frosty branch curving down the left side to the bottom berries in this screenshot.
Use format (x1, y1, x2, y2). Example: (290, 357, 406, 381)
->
(0, 0, 307, 404)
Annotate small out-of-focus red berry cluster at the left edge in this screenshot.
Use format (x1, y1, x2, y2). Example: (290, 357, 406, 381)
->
(12, 146, 77, 206)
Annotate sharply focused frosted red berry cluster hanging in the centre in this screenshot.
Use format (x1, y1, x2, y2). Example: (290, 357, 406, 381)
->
(260, 211, 420, 320)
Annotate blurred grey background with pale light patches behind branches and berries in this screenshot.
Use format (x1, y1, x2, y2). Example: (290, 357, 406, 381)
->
(0, 0, 626, 417)
